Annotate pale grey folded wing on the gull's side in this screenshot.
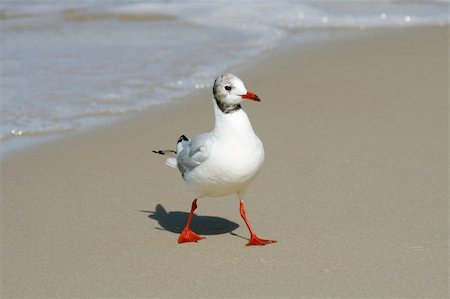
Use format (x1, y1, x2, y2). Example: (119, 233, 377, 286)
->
(176, 133, 212, 174)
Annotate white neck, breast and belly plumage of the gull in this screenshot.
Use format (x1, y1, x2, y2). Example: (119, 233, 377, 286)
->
(177, 101, 264, 198)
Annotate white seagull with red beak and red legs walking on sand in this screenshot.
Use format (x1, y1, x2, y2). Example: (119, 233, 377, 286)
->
(153, 73, 276, 246)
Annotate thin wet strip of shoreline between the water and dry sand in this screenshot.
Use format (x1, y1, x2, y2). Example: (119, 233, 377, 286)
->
(0, 25, 442, 160)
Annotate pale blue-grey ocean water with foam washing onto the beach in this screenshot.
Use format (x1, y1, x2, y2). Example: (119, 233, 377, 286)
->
(0, 0, 449, 153)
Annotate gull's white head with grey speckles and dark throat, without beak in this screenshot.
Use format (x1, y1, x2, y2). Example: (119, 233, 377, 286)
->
(213, 73, 247, 114)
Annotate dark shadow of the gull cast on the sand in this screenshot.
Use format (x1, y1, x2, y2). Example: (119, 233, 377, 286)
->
(140, 204, 239, 235)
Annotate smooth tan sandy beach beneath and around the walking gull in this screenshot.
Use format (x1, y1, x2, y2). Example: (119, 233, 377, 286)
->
(0, 27, 449, 298)
